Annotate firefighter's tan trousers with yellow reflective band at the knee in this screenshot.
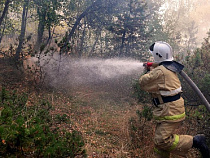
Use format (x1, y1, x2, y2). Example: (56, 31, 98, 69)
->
(154, 122, 193, 158)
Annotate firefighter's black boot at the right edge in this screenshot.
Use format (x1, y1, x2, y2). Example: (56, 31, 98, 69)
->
(192, 134, 210, 158)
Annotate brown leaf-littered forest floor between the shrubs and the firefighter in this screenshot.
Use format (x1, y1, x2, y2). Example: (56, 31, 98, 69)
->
(0, 58, 200, 158)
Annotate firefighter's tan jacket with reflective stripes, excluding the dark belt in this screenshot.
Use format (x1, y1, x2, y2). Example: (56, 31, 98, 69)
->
(139, 65, 185, 122)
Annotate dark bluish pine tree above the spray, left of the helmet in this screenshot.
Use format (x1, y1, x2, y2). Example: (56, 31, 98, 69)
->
(107, 0, 152, 59)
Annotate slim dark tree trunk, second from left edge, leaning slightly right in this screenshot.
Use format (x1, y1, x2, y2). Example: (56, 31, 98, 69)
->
(15, 0, 29, 61)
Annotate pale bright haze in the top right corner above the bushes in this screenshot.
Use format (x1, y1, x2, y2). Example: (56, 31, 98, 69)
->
(159, 0, 210, 47)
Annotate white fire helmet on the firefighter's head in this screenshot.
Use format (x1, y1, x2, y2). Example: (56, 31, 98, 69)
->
(149, 41, 174, 63)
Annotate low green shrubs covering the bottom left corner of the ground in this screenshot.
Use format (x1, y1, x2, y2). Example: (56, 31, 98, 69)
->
(0, 88, 86, 157)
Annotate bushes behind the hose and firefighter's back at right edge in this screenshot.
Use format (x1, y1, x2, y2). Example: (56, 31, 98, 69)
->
(180, 30, 210, 144)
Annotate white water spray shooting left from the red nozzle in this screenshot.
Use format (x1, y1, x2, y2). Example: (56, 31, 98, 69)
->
(42, 57, 143, 101)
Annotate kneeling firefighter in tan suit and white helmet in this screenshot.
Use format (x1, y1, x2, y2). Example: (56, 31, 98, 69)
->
(139, 41, 210, 158)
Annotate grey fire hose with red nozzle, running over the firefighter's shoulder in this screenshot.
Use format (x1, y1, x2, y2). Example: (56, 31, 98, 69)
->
(143, 61, 210, 112)
